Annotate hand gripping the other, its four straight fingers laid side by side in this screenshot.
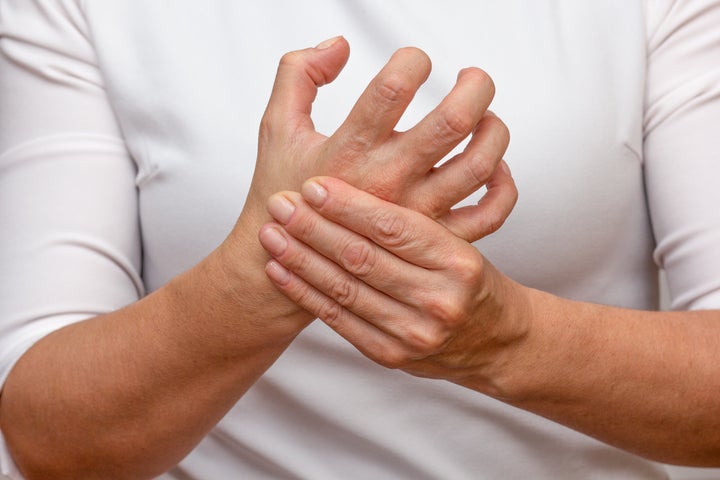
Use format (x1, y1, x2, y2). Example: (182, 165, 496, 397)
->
(260, 174, 528, 394)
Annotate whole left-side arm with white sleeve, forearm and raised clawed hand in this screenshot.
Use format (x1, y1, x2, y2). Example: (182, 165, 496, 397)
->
(0, 1, 506, 478)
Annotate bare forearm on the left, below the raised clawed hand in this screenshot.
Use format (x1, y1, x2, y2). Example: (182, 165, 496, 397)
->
(0, 240, 309, 479)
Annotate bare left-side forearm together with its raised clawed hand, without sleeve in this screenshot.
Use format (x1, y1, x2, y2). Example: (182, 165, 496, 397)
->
(0, 31, 507, 478)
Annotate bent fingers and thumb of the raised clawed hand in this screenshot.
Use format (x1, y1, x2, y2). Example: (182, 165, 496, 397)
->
(259, 37, 517, 246)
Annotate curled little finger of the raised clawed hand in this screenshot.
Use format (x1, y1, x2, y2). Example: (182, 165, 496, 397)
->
(438, 160, 518, 242)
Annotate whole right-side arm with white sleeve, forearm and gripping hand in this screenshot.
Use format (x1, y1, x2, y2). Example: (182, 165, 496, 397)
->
(261, 0, 720, 466)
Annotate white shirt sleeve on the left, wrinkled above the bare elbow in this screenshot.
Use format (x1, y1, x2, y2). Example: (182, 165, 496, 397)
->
(0, 0, 144, 478)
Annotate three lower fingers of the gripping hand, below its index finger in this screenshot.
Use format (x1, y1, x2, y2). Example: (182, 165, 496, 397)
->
(259, 195, 477, 366)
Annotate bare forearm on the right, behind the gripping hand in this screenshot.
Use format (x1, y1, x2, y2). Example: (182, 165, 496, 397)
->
(486, 289, 720, 466)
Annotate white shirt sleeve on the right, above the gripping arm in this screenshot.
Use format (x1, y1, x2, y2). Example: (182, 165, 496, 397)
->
(644, 0, 720, 310)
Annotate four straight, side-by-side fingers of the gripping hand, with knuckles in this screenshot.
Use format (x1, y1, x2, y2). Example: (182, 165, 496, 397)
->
(260, 186, 487, 367)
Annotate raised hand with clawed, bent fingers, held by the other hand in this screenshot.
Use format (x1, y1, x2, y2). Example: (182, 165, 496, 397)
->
(236, 37, 509, 244)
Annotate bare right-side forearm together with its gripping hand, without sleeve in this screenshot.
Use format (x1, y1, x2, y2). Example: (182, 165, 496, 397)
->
(261, 178, 720, 466)
